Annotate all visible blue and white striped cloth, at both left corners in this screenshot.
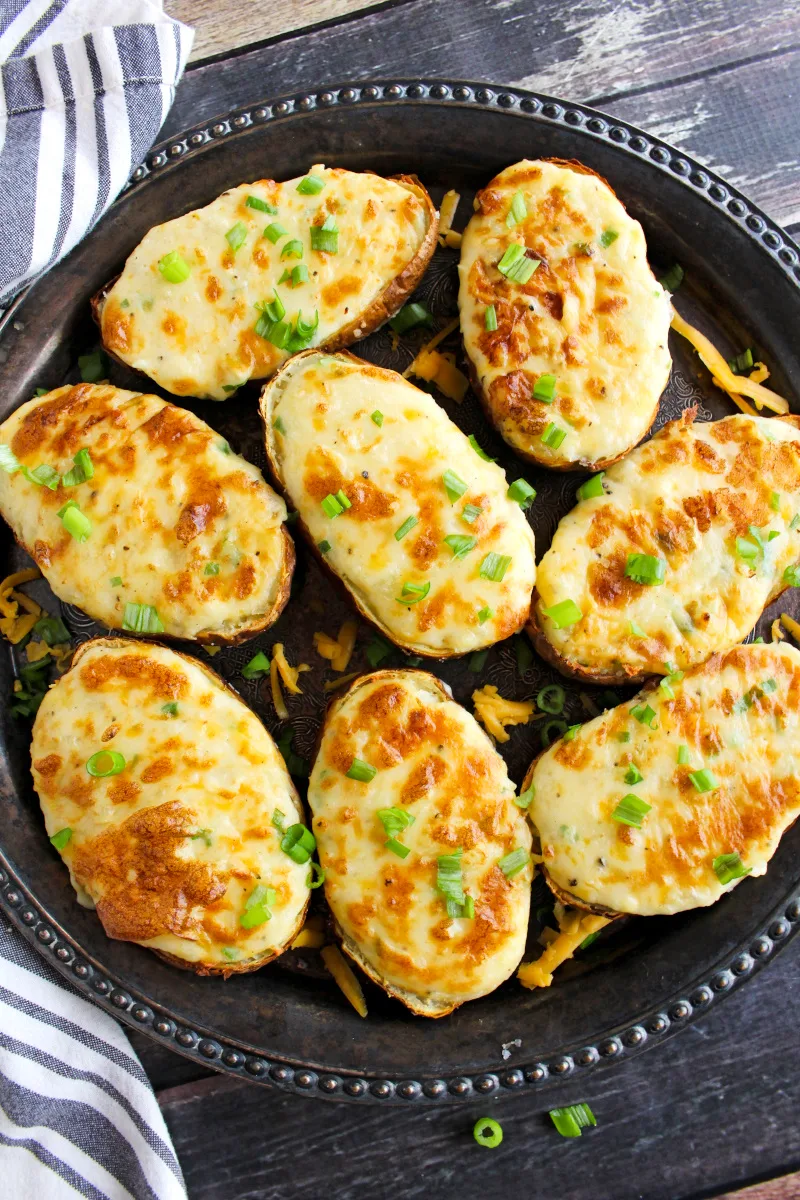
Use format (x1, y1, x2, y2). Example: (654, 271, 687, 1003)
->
(0, 0, 192, 1200)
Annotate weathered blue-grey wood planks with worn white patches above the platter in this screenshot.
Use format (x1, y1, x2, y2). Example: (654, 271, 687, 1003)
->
(166, 0, 800, 229)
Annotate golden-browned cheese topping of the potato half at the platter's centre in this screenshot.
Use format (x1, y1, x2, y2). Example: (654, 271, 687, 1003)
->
(264, 354, 535, 655)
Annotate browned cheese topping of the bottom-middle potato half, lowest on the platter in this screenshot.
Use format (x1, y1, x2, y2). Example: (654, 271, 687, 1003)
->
(308, 671, 533, 1015)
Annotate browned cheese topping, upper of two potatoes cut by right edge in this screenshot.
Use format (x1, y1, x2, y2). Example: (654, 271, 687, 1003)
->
(536, 412, 800, 677)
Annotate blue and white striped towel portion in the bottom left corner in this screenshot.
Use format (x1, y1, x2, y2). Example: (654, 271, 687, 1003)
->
(0, 916, 186, 1200)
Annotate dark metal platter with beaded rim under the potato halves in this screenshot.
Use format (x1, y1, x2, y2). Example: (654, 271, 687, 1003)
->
(0, 83, 800, 1103)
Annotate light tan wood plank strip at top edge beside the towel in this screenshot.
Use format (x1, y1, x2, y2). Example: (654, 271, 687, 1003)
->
(164, 0, 391, 62)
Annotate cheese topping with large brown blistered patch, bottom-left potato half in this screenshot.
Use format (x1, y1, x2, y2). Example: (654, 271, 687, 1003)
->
(31, 638, 309, 970)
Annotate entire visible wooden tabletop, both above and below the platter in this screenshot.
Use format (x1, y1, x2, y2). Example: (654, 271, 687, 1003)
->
(145, 0, 800, 1200)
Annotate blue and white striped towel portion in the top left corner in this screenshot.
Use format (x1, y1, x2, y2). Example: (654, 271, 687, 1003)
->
(0, 0, 193, 307)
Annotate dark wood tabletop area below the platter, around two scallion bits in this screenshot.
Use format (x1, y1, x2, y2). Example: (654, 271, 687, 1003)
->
(154, 944, 800, 1200)
